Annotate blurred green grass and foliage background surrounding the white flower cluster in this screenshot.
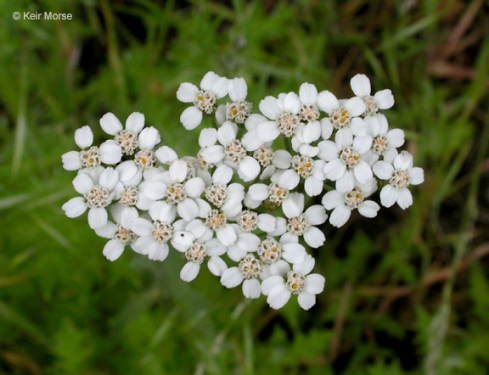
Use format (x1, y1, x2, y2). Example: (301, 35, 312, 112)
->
(0, 0, 489, 375)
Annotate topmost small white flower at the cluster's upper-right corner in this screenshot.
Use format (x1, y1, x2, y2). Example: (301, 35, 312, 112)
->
(350, 74, 394, 116)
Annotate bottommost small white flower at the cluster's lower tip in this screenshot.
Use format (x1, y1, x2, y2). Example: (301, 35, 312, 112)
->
(262, 255, 325, 310)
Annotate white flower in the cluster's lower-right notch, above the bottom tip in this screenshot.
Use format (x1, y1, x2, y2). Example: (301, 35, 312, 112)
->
(282, 193, 328, 248)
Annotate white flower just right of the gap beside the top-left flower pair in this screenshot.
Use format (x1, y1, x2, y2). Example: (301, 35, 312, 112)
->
(256, 92, 301, 142)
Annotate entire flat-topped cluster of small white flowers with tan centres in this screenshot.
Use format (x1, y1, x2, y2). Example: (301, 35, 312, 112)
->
(62, 72, 424, 310)
